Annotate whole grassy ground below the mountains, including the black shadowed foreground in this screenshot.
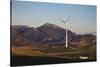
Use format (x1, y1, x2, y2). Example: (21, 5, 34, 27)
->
(11, 43, 96, 66)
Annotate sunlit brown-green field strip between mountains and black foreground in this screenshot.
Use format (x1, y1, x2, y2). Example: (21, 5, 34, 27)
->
(12, 46, 96, 59)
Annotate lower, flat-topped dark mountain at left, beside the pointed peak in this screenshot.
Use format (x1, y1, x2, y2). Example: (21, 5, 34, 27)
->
(12, 26, 45, 43)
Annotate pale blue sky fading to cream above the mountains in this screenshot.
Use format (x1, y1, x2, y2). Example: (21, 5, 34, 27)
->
(11, 1, 96, 34)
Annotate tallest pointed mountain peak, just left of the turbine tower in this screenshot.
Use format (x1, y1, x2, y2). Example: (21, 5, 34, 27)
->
(36, 23, 66, 44)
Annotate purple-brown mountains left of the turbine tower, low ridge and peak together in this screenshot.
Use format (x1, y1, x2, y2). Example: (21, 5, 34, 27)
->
(11, 23, 66, 45)
